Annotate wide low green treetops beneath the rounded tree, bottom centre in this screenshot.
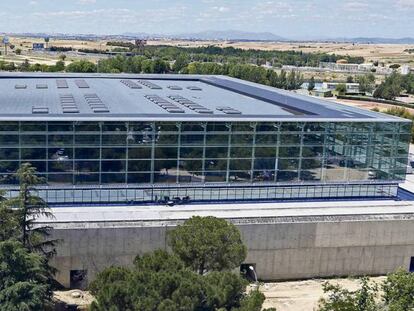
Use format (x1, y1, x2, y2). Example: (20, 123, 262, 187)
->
(91, 251, 264, 311)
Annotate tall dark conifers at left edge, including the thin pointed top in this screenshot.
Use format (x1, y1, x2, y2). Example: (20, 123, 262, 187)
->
(0, 164, 55, 311)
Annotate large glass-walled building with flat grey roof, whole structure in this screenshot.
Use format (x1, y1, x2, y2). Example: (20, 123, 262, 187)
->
(0, 73, 411, 204)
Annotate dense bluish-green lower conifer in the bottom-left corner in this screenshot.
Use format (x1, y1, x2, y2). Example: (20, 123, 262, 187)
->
(0, 240, 52, 311)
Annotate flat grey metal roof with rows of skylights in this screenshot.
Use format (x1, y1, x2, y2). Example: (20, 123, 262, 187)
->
(0, 73, 407, 122)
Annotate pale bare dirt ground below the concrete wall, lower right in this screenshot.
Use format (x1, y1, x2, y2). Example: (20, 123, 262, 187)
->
(260, 277, 385, 311)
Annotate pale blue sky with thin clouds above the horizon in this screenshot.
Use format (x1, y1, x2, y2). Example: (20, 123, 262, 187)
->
(0, 0, 414, 39)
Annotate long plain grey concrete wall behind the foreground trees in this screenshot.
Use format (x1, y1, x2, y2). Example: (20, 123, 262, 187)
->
(53, 217, 414, 286)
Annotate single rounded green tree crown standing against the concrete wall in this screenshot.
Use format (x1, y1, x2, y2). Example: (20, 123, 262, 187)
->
(169, 216, 247, 274)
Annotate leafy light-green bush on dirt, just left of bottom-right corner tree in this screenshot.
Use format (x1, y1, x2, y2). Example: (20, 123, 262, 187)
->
(319, 277, 380, 311)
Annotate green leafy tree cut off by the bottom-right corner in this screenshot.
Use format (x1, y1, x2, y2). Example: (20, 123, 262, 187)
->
(382, 269, 414, 311)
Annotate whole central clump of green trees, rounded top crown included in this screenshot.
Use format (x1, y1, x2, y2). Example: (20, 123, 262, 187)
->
(90, 217, 271, 311)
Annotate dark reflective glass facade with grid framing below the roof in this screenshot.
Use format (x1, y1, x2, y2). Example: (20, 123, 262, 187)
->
(0, 121, 411, 205)
